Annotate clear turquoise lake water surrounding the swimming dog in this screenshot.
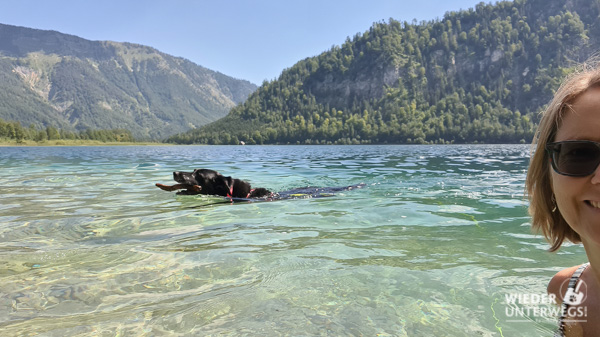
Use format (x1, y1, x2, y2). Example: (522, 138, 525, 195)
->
(0, 145, 586, 336)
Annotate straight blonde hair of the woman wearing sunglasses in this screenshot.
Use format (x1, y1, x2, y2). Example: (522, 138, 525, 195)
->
(525, 57, 600, 252)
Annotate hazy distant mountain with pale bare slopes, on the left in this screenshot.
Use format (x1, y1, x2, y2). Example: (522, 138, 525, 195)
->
(0, 24, 256, 140)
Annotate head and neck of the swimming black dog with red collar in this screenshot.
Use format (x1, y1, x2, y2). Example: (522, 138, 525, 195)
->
(173, 169, 250, 198)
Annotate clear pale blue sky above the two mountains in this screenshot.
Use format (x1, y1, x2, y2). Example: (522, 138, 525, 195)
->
(0, 0, 488, 85)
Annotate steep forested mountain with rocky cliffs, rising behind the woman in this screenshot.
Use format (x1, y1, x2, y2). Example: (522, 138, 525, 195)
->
(169, 0, 600, 144)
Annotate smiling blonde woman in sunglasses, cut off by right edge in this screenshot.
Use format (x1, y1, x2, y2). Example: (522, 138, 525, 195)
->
(526, 62, 600, 336)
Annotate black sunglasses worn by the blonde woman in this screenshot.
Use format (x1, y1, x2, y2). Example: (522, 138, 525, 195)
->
(546, 140, 600, 177)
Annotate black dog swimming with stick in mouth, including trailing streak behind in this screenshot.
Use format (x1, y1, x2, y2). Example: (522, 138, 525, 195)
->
(156, 169, 364, 200)
